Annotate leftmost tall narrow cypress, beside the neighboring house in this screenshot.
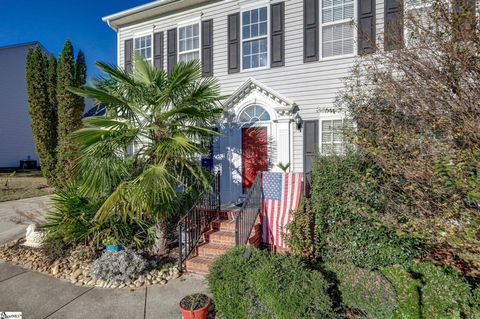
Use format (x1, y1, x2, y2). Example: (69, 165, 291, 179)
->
(26, 45, 57, 186)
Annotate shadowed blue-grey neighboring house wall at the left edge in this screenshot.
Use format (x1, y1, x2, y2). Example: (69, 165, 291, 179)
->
(0, 42, 41, 168)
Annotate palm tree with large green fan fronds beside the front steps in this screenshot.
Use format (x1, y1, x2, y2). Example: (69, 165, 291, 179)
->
(70, 57, 222, 254)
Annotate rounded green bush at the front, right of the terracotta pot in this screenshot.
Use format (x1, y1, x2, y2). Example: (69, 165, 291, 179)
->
(207, 247, 336, 319)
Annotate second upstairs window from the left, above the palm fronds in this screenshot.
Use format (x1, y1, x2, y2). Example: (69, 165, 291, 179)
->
(178, 23, 200, 62)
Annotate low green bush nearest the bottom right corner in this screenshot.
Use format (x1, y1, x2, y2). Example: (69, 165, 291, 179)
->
(408, 262, 472, 319)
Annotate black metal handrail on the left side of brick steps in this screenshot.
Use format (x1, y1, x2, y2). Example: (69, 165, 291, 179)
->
(178, 172, 220, 269)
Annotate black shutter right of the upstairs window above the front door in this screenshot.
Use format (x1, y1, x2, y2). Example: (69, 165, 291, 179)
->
(270, 2, 285, 68)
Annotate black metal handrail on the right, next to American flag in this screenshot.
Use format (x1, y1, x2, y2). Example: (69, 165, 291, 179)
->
(235, 173, 262, 246)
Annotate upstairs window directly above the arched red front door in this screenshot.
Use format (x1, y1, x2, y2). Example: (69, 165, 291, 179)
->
(242, 7, 268, 70)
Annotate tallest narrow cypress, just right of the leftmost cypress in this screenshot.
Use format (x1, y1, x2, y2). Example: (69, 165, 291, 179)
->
(57, 40, 83, 185)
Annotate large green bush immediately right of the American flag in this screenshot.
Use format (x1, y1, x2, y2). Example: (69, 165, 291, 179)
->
(289, 152, 420, 269)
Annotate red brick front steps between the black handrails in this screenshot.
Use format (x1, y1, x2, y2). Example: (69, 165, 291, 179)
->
(186, 216, 235, 275)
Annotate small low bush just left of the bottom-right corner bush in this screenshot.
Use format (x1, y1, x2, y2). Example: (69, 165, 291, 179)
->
(382, 265, 421, 319)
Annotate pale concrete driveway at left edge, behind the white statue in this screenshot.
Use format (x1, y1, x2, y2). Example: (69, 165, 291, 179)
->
(0, 195, 52, 245)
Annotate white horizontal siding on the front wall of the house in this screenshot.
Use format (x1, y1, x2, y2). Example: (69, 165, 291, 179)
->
(117, 0, 384, 174)
